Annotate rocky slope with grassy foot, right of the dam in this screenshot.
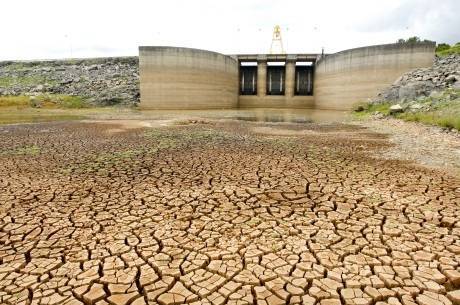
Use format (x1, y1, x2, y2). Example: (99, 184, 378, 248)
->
(362, 54, 460, 131)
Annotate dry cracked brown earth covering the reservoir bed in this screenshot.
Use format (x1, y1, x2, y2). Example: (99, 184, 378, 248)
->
(0, 121, 460, 305)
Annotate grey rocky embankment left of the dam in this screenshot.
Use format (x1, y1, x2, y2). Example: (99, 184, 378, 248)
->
(0, 57, 139, 106)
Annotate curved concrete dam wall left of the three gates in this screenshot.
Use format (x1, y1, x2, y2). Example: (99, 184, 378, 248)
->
(139, 47, 238, 109)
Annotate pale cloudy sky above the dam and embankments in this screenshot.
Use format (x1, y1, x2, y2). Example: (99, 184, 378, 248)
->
(0, 0, 460, 60)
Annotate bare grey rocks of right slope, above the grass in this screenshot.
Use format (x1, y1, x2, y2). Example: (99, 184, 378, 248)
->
(375, 55, 460, 103)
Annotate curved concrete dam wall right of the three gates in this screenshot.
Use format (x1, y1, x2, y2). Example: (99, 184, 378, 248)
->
(314, 42, 436, 110)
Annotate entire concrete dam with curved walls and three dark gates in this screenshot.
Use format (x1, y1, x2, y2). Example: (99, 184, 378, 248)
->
(139, 42, 436, 110)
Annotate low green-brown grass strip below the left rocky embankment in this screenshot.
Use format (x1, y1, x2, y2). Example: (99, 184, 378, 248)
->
(0, 94, 90, 109)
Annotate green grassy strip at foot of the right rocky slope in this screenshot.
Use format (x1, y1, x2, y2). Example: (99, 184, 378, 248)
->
(354, 89, 460, 131)
